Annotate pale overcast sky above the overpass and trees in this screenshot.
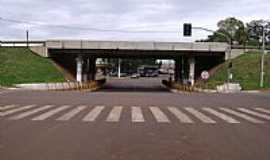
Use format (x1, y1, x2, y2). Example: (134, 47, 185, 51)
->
(0, 0, 270, 41)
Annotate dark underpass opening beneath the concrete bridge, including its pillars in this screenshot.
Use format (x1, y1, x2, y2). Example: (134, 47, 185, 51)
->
(49, 49, 225, 92)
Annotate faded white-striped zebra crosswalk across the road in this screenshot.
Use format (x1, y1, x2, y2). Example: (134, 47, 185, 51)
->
(0, 104, 270, 124)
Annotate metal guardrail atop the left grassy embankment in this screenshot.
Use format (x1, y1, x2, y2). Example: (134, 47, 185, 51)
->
(0, 41, 46, 47)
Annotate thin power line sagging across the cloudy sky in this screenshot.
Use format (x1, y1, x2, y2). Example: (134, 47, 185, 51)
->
(0, 17, 177, 33)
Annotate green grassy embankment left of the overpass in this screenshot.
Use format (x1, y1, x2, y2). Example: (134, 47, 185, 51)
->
(0, 47, 65, 86)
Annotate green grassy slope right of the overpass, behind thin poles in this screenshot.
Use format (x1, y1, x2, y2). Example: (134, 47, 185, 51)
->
(207, 52, 270, 90)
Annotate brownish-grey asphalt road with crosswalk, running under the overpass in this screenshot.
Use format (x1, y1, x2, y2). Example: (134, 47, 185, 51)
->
(0, 79, 270, 160)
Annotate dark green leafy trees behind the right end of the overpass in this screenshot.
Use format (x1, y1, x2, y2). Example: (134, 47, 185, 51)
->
(197, 17, 270, 48)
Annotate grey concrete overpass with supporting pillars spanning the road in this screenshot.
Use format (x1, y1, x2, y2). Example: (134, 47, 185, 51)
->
(28, 40, 229, 84)
